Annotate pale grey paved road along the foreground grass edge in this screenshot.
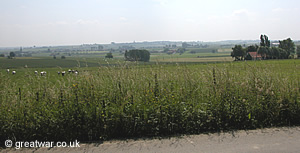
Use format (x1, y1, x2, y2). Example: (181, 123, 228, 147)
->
(0, 127, 300, 153)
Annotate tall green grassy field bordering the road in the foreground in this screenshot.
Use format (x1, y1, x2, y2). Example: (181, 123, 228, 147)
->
(0, 59, 300, 141)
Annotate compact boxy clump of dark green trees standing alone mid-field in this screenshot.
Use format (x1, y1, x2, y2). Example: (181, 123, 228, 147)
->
(125, 49, 150, 62)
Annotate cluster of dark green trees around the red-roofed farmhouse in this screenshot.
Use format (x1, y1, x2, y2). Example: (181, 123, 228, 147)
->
(231, 35, 300, 60)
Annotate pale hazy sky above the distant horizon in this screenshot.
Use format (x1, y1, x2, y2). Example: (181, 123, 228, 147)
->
(0, 0, 300, 47)
